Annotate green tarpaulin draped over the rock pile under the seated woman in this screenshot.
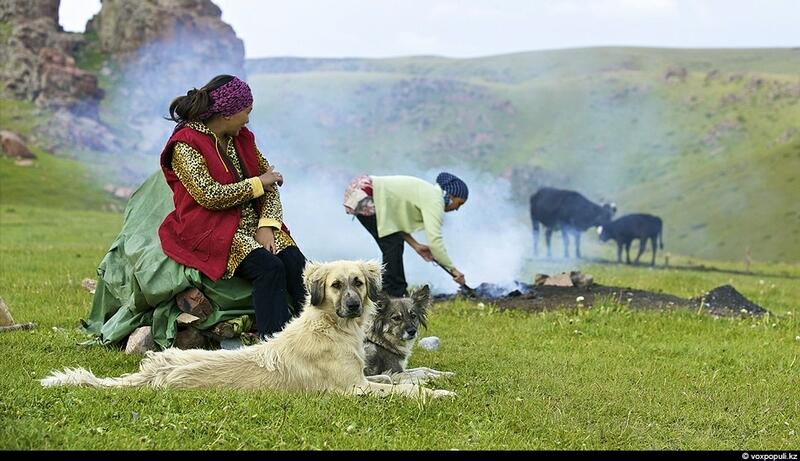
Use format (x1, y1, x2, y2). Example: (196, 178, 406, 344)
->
(84, 171, 254, 349)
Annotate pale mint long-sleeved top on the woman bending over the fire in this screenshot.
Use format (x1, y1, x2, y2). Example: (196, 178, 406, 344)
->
(371, 176, 455, 269)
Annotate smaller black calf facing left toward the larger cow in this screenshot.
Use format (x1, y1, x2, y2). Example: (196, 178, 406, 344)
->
(597, 214, 664, 266)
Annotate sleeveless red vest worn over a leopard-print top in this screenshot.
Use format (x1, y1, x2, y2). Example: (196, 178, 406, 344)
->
(158, 127, 261, 280)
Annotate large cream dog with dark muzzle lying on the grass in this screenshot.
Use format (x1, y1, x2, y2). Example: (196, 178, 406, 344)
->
(41, 261, 454, 397)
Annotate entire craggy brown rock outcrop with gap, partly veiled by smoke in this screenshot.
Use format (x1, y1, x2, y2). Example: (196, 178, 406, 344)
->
(0, 0, 244, 162)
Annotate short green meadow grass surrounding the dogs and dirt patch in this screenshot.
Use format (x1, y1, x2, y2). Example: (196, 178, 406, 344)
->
(0, 201, 800, 450)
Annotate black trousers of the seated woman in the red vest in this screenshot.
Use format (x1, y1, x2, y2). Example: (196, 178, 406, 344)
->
(235, 247, 305, 336)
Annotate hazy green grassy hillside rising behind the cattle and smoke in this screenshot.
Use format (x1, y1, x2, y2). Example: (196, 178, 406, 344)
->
(248, 48, 800, 261)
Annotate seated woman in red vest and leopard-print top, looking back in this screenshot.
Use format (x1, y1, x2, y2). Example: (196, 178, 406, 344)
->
(158, 75, 306, 337)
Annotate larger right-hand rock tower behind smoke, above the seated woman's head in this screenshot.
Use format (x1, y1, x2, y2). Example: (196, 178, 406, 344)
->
(86, 0, 244, 154)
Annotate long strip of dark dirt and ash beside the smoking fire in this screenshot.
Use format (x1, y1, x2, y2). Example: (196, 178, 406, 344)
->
(434, 282, 768, 316)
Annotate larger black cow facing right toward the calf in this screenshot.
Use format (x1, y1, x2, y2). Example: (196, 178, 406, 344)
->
(531, 187, 617, 258)
